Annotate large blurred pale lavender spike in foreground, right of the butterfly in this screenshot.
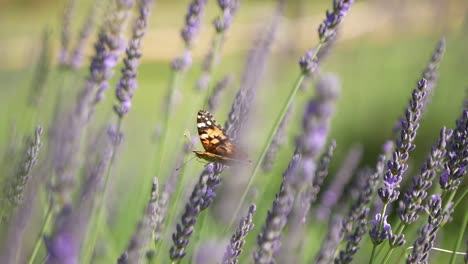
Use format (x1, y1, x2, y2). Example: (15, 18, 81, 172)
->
(281, 72, 338, 262)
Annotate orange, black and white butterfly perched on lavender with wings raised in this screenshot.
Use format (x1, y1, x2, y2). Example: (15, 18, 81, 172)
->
(193, 110, 251, 165)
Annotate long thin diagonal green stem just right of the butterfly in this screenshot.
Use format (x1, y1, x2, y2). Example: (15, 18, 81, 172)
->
(223, 73, 305, 233)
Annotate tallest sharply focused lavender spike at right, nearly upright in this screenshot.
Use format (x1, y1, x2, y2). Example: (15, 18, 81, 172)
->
(378, 79, 427, 204)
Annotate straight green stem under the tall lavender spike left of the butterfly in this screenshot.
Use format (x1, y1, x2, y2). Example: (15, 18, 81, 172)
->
(83, 118, 122, 263)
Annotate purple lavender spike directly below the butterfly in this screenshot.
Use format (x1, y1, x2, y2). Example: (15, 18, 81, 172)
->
(169, 163, 215, 260)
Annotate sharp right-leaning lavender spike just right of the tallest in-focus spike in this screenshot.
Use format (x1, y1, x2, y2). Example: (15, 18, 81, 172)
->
(397, 127, 452, 225)
